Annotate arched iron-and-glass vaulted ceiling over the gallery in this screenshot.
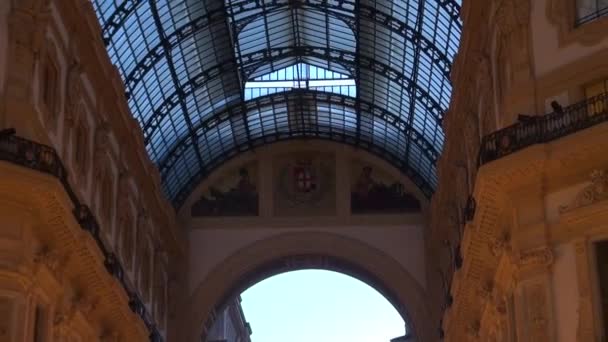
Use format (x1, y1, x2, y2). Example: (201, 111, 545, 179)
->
(93, 0, 461, 207)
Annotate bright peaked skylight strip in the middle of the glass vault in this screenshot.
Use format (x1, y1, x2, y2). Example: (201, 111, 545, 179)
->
(245, 63, 357, 100)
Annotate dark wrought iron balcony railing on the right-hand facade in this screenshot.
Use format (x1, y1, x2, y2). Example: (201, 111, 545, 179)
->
(479, 93, 608, 165)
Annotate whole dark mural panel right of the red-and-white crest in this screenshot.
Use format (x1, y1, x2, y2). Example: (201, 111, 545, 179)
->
(350, 161, 420, 214)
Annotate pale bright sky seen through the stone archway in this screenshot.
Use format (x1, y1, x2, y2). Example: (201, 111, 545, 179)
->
(241, 270, 405, 342)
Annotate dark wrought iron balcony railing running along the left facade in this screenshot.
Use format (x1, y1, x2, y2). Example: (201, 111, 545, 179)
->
(0, 130, 162, 342)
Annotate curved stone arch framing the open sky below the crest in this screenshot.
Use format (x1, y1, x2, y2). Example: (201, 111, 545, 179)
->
(185, 232, 433, 341)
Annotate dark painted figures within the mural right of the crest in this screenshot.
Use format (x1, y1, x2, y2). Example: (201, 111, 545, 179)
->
(351, 166, 420, 214)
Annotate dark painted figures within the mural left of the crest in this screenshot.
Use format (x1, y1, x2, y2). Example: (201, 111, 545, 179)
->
(191, 168, 258, 216)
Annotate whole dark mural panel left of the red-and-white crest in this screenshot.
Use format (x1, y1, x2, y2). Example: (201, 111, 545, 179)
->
(191, 163, 258, 216)
